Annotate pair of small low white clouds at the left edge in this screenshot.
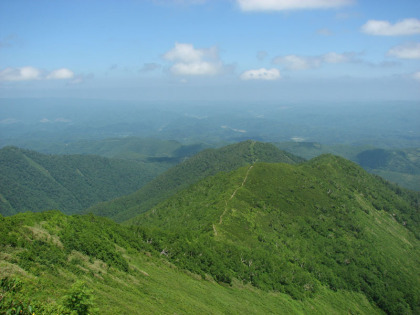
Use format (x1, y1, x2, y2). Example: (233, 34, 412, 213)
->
(0, 66, 74, 81)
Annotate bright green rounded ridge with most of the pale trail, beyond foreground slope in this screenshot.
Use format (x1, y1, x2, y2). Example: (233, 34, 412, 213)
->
(136, 155, 420, 314)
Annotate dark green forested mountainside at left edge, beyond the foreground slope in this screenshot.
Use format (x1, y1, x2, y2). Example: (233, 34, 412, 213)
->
(0, 147, 163, 215)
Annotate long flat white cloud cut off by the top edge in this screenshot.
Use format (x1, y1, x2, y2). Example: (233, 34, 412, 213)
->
(236, 0, 354, 11)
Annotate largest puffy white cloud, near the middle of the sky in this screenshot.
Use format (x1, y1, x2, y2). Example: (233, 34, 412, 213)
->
(163, 43, 223, 75)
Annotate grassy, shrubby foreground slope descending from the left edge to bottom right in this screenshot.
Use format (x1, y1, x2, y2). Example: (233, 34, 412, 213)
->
(0, 211, 380, 314)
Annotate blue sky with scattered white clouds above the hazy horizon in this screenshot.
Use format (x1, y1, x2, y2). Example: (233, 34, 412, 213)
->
(0, 0, 420, 102)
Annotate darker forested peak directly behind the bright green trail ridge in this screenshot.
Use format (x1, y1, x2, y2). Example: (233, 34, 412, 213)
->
(87, 141, 303, 222)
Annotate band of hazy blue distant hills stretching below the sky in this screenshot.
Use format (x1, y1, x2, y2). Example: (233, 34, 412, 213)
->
(0, 99, 420, 149)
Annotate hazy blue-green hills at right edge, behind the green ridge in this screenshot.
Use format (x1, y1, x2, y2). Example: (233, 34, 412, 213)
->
(276, 142, 420, 191)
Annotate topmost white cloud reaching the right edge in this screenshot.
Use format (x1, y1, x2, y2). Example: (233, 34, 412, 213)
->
(361, 19, 420, 36)
